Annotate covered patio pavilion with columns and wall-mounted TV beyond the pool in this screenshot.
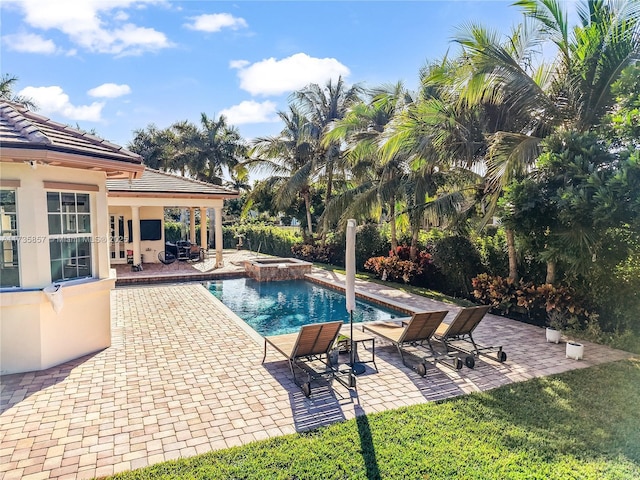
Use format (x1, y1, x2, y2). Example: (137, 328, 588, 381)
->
(107, 168, 238, 266)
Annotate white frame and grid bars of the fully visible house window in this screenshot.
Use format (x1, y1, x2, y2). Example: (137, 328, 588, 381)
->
(46, 190, 95, 283)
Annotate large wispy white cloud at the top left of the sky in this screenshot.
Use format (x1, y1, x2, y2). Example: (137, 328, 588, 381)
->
(14, 0, 171, 56)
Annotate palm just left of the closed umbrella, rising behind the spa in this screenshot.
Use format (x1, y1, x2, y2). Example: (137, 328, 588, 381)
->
(244, 105, 317, 239)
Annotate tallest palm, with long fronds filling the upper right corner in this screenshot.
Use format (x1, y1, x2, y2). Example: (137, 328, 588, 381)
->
(456, 0, 640, 282)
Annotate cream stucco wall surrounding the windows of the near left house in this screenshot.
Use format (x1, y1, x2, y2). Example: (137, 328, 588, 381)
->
(0, 162, 115, 374)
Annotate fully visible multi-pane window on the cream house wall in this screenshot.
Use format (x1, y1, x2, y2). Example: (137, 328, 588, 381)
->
(47, 192, 92, 282)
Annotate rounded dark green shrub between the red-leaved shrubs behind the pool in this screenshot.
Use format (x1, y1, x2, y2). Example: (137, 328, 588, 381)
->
(433, 235, 483, 298)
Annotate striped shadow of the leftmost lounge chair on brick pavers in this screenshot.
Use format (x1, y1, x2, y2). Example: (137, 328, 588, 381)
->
(262, 361, 357, 432)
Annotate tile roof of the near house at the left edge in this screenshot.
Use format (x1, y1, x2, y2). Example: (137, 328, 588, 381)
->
(0, 100, 142, 164)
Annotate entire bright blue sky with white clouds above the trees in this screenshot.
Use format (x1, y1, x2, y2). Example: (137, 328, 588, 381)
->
(0, 0, 521, 146)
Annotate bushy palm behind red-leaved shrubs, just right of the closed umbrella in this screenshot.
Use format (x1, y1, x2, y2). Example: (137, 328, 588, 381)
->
(382, 61, 483, 258)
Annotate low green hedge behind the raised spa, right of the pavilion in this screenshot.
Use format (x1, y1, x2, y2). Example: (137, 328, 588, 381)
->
(222, 225, 301, 257)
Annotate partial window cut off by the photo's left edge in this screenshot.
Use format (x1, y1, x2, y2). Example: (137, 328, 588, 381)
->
(0, 190, 20, 287)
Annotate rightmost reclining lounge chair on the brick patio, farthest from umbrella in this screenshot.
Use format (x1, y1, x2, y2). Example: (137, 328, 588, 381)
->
(434, 305, 507, 368)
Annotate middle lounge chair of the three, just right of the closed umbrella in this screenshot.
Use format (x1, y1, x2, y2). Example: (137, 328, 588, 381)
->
(362, 310, 462, 377)
